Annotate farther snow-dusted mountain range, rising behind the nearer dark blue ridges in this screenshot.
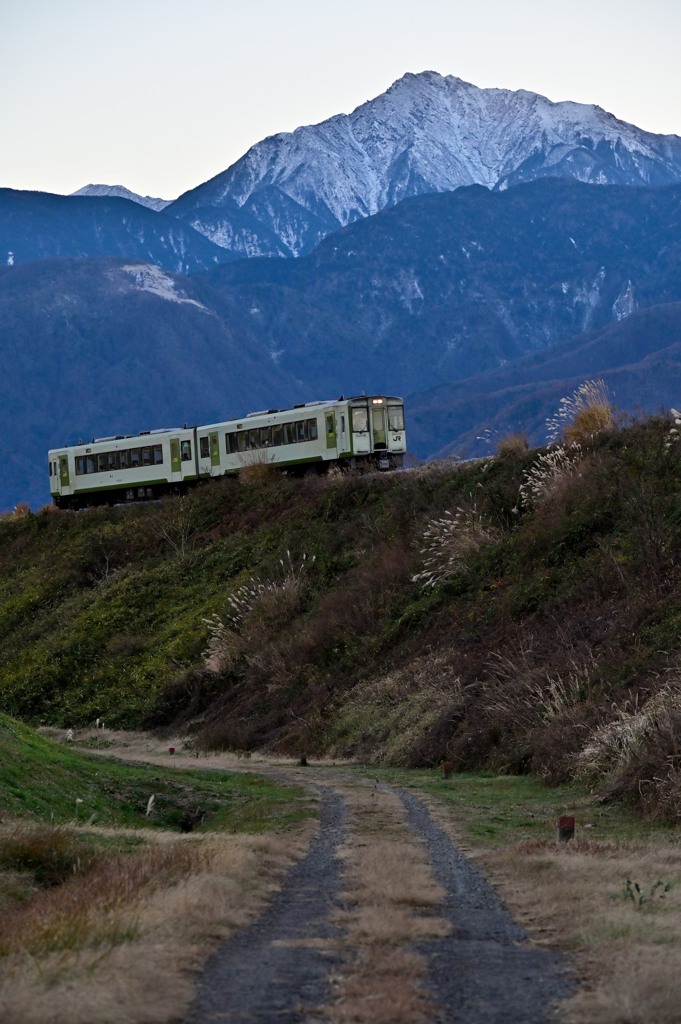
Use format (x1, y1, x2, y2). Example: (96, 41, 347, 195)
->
(5, 72, 681, 272)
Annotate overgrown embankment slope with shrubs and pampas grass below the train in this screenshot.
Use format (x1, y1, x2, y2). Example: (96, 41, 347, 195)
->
(0, 403, 681, 817)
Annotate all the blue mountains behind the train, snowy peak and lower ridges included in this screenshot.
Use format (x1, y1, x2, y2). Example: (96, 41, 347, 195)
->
(0, 73, 681, 511)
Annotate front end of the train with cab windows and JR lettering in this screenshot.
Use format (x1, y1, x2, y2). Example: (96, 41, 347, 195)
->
(343, 395, 407, 469)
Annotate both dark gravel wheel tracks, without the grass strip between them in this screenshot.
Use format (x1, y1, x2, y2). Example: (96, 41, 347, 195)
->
(185, 775, 572, 1024)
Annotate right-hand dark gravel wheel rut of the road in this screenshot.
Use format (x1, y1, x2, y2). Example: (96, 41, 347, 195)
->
(397, 791, 573, 1024)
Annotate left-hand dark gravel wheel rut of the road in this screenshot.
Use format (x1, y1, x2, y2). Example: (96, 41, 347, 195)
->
(186, 787, 346, 1024)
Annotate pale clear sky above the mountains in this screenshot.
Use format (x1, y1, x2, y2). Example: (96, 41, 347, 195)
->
(0, 0, 681, 199)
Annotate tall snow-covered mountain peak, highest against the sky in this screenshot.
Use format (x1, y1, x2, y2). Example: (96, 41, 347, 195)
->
(168, 72, 681, 256)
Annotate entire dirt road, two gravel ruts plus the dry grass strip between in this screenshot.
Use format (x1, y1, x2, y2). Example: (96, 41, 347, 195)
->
(185, 768, 571, 1024)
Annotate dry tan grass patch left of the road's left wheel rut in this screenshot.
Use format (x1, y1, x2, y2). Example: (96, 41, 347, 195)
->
(0, 761, 314, 1024)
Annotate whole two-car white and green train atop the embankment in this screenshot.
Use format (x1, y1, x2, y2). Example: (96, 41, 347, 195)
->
(48, 395, 407, 509)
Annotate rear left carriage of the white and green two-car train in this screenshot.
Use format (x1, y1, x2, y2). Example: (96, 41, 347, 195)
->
(48, 427, 198, 509)
